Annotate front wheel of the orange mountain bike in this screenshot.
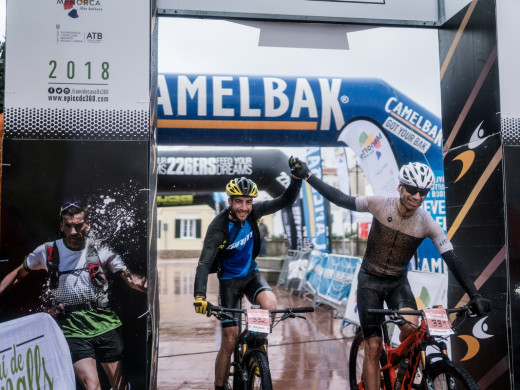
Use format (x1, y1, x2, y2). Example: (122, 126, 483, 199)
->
(422, 360, 479, 390)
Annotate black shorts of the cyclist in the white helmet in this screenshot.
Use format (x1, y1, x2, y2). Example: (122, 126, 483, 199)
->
(357, 269, 417, 338)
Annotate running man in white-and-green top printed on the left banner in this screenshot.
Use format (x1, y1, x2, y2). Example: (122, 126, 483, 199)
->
(0, 201, 147, 390)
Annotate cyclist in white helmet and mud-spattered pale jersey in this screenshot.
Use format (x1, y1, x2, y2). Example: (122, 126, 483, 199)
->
(289, 157, 491, 389)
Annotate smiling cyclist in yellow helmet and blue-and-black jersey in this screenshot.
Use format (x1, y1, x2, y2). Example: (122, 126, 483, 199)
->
(194, 177, 302, 390)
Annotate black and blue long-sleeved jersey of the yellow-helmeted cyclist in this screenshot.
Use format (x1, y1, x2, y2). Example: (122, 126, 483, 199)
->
(194, 178, 302, 297)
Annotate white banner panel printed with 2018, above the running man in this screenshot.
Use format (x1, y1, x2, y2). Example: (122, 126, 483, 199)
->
(5, 0, 150, 139)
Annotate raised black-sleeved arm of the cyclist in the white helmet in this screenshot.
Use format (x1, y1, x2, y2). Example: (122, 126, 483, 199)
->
(289, 157, 357, 211)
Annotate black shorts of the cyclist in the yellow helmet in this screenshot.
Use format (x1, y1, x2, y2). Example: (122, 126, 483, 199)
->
(218, 271, 273, 328)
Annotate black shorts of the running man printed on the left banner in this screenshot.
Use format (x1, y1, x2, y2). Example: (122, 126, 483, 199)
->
(66, 328, 123, 364)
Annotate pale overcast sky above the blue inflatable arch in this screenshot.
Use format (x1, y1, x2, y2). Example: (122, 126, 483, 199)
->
(159, 17, 441, 116)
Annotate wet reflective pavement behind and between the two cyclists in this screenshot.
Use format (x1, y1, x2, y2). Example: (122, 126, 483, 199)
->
(157, 259, 358, 390)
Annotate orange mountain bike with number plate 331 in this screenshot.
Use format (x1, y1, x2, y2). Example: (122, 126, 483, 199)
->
(349, 306, 478, 390)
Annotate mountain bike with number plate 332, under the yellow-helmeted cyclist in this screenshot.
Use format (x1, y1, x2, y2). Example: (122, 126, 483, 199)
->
(198, 302, 314, 390)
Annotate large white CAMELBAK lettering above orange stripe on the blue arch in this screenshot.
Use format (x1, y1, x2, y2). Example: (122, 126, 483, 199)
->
(157, 75, 349, 130)
